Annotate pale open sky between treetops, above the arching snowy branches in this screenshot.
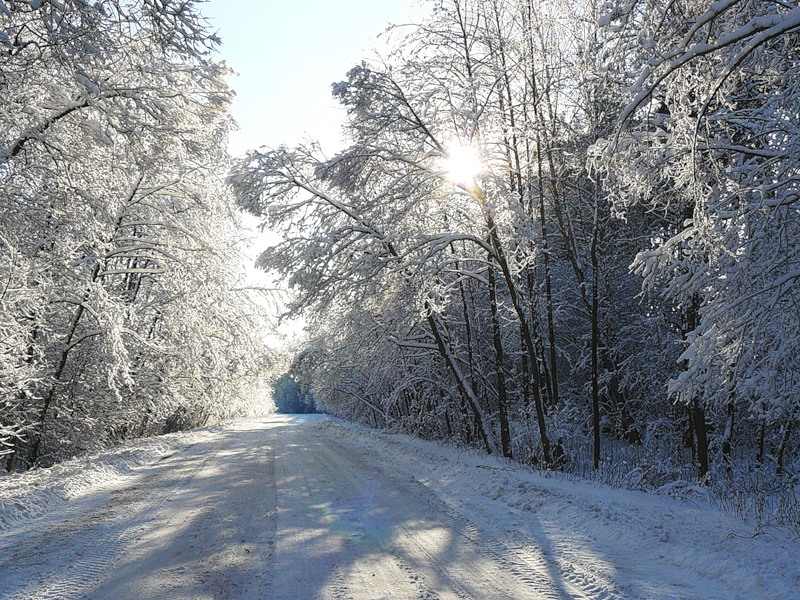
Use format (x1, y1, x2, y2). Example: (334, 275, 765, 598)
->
(201, 0, 416, 155)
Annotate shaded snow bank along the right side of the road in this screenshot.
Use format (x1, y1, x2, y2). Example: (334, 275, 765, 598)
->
(314, 420, 800, 598)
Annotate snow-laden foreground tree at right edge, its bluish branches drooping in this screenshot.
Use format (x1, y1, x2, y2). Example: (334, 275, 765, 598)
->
(595, 0, 800, 473)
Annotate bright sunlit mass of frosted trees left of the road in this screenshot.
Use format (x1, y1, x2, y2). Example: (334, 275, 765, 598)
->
(0, 0, 272, 468)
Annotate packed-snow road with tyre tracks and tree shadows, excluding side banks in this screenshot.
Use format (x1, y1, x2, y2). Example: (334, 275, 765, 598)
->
(0, 416, 622, 600)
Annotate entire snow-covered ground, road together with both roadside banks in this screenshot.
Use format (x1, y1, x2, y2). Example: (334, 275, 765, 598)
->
(0, 415, 800, 600)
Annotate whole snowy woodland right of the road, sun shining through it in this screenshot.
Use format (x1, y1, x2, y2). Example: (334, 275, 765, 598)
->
(230, 0, 800, 494)
